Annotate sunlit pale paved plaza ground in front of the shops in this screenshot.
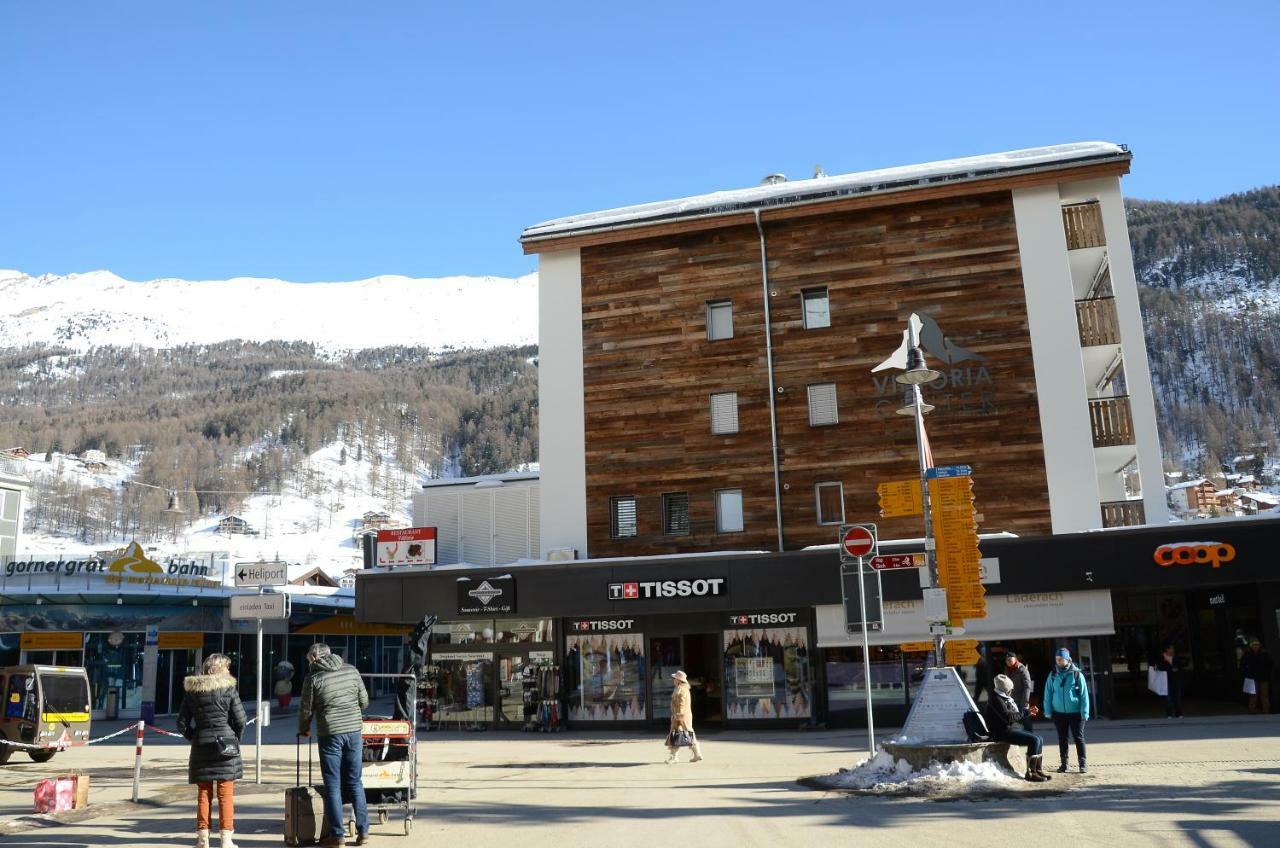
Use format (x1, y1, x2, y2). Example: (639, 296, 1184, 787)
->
(0, 716, 1280, 848)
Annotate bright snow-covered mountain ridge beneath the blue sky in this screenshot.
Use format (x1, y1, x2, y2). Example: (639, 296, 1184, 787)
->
(0, 270, 538, 351)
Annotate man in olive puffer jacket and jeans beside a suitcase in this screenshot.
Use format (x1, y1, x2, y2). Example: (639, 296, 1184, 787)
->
(298, 642, 369, 848)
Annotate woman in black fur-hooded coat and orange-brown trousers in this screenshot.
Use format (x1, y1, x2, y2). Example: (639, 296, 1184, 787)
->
(178, 653, 247, 848)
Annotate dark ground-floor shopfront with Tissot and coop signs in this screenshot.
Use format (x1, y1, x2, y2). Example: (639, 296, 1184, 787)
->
(356, 520, 1280, 728)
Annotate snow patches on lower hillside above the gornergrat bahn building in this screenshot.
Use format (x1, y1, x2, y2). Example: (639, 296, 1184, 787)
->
(19, 442, 420, 576)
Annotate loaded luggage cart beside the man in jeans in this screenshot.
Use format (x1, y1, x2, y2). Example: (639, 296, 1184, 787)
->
(332, 674, 417, 836)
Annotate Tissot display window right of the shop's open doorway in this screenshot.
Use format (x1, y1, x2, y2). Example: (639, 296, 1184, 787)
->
(724, 628, 813, 721)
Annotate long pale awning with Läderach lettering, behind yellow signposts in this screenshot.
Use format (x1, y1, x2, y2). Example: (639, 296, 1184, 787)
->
(815, 589, 1115, 648)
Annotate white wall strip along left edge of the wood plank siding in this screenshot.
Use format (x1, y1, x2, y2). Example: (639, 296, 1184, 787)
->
(538, 250, 588, 559)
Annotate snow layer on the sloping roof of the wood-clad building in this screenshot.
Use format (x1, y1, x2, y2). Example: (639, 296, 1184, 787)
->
(520, 141, 1129, 242)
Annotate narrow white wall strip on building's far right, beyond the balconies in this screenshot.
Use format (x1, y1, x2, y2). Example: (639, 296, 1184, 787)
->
(1071, 177, 1169, 524)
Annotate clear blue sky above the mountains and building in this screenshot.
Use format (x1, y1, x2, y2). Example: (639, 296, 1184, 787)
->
(0, 0, 1280, 281)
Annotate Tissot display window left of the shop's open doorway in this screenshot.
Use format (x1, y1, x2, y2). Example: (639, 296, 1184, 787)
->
(564, 633, 645, 721)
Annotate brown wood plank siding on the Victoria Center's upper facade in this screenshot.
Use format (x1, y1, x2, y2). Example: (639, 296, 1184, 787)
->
(581, 191, 1051, 557)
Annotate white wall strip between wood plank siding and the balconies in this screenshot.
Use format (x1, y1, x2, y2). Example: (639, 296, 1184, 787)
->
(1012, 186, 1102, 533)
